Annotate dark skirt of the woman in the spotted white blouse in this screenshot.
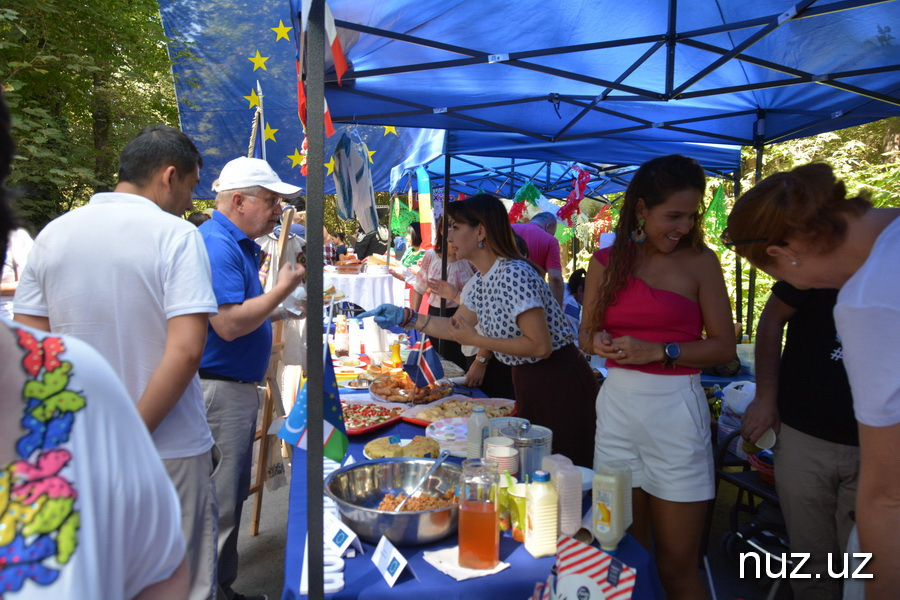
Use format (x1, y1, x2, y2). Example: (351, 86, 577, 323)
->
(512, 344, 600, 468)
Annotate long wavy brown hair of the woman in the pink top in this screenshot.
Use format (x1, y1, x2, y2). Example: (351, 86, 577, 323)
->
(586, 154, 706, 333)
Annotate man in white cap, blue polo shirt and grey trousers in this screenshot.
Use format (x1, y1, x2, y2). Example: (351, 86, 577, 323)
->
(199, 157, 306, 600)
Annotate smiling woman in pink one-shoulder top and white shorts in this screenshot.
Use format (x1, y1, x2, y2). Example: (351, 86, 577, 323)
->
(579, 155, 735, 600)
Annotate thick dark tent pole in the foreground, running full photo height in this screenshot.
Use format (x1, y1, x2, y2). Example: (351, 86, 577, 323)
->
(306, 0, 325, 599)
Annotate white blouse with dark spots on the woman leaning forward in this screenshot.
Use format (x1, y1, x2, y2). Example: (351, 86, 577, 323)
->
(462, 258, 575, 365)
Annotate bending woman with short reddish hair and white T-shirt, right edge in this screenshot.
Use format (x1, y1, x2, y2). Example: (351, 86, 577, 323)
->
(722, 163, 900, 600)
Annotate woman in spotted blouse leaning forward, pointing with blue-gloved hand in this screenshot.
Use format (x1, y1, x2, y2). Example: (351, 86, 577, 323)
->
(358, 194, 597, 466)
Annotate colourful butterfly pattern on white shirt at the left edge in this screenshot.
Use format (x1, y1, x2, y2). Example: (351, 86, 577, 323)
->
(0, 329, 85, 597)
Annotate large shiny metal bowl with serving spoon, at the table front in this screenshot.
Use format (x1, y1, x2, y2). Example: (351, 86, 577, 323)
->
(325, 458, 462, 546)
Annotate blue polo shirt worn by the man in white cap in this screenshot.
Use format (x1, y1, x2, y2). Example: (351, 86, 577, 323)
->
(199, 210, 272, 381)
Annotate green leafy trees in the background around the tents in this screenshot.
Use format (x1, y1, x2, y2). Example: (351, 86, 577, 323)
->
(0, 0, 900, 338)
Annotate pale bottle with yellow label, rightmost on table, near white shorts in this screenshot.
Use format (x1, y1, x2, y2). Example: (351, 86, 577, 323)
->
(593, 462, 631, 554)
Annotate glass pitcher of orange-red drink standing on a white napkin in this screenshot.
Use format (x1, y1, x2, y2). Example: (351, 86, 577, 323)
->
(459, 458, 500, 569)
